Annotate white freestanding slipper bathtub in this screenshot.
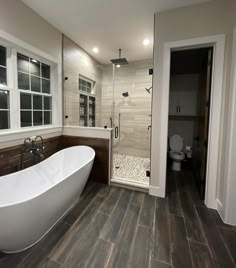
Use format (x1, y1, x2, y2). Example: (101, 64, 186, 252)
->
(0, 146, 95, 253)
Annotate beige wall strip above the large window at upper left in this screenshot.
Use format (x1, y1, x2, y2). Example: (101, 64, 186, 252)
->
(0, 0, 62, 59)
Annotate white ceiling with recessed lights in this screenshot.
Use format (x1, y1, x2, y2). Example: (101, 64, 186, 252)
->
(22, 0, 207, 63)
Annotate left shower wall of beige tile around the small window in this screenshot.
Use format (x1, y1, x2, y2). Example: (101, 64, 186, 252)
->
(63, 36, 102, 127)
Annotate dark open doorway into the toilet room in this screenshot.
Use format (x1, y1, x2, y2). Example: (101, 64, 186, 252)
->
(167, 46, 214, 200)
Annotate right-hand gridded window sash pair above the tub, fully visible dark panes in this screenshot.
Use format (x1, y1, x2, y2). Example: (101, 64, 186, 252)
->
(17, 53, 52, 127)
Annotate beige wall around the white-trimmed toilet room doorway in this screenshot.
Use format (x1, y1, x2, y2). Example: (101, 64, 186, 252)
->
(151, 0, 234, 203)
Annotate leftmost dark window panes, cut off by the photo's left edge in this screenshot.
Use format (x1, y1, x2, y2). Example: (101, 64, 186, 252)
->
(0, 46, 10, 129)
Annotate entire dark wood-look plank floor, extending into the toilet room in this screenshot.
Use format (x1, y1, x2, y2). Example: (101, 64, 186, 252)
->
(0, 171, 236, 268)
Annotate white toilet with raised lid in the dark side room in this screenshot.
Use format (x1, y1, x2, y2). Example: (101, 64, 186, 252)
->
(169, 134, 185, 171)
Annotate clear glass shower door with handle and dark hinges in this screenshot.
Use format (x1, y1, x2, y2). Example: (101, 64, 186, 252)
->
(110, 60, 153, 187)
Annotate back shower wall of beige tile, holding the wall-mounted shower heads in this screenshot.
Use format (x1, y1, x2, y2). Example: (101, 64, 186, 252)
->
(102, 60, 153, 157)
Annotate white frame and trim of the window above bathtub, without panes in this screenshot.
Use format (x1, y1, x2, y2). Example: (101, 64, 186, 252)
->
(0, 31, 62, 138)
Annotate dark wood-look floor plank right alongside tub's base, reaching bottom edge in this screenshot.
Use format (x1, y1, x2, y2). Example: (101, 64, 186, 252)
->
(18, 222, 70, 268)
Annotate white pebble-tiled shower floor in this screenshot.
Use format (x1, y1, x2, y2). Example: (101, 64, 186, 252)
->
(113, 154, 150, 186)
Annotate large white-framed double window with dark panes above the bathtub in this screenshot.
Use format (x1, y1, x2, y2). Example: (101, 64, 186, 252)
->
(0, 32, 58, 135)
